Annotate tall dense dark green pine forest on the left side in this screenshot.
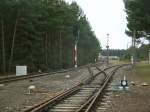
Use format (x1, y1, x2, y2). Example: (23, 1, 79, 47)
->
(0, 0, 101, 73)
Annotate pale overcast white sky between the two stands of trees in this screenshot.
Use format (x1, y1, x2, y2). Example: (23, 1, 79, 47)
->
(66, 0, 131, 49)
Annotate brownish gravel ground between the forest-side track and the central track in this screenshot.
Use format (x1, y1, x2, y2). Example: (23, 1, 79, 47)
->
(0, 65, 103, 112)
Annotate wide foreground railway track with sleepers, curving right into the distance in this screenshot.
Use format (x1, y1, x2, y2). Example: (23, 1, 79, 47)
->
(24, 65, 129, 112)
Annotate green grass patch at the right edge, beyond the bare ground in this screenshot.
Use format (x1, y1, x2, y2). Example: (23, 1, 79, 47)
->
(135, 64, 150, 82)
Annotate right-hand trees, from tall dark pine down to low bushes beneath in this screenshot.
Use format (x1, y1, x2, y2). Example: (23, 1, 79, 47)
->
(124, 0, 150, 60)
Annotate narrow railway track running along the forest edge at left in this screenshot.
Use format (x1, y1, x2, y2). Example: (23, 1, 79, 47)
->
(0, 63, 102, 84)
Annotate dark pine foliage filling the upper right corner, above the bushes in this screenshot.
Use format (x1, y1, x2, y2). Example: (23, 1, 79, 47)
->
(125, 0, 150, 40)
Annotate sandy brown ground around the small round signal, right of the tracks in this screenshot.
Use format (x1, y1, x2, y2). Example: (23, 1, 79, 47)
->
(97, 67, 150, 112)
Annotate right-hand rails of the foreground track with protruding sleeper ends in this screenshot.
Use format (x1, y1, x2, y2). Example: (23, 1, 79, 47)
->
(81, 65, 126, 112)
